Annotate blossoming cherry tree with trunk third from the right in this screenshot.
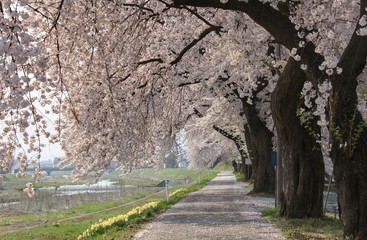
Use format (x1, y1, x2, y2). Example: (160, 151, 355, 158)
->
(171, 10, 280, 192)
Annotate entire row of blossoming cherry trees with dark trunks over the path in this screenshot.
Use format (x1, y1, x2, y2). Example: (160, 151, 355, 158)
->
(0, 0, 367, 239)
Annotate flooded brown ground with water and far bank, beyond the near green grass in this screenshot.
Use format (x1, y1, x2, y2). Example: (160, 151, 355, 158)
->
(0, 169, 197, 216)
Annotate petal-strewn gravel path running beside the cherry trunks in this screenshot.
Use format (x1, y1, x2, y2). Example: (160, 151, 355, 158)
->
(133, 172, 286, 240)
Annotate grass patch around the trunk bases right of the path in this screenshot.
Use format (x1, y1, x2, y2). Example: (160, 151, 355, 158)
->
(261, 208, 343, 240)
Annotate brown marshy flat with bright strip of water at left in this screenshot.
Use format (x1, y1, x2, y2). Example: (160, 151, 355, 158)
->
(0, 173, 162, 216)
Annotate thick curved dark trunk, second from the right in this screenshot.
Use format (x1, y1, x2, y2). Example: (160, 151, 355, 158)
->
(271, 58, 324, 218)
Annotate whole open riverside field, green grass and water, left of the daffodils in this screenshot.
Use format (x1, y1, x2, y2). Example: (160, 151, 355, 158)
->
(0, 169, 216, 240)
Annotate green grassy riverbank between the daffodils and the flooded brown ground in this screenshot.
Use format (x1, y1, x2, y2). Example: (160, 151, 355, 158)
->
(0, 169, 216, 240)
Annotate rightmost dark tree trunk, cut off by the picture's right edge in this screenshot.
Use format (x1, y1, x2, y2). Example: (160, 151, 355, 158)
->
(330, 20, 367, 240)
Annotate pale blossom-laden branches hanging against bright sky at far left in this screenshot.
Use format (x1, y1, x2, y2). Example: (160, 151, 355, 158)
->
(0, 1, 57, 184)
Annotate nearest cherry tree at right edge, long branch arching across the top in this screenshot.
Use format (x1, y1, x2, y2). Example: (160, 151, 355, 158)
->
(175, 0, 367, 236)
